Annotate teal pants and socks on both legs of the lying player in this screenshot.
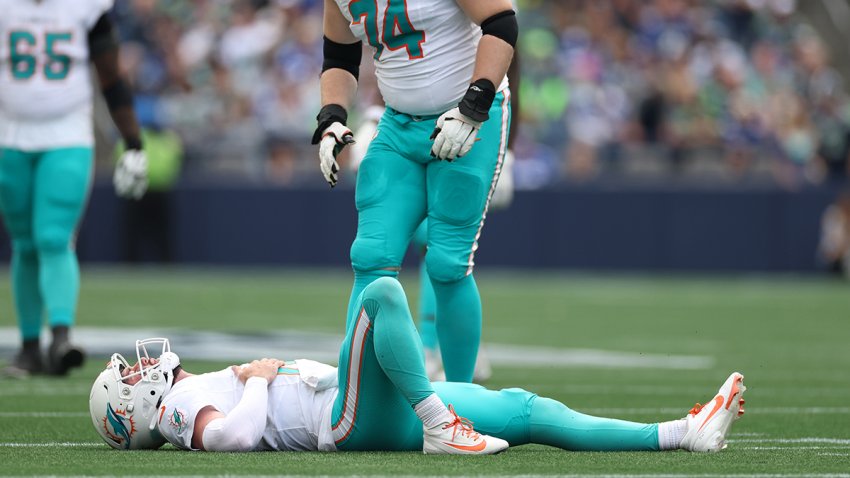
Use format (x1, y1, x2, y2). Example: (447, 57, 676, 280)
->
(331, 278, 659, 451)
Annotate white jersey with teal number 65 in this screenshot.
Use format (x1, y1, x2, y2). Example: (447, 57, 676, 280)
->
(0, 0, 113, 150)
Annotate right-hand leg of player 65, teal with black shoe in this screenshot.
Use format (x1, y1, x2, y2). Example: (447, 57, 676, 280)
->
(33, 147, 93, 375)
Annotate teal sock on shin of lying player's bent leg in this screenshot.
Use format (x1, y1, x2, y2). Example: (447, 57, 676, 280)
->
(363, 280, 434, 406)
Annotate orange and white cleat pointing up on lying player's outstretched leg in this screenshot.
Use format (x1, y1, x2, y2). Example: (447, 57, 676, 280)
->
(679, 372, 747, 452)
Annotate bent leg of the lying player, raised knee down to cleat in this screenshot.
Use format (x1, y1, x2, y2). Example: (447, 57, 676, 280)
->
(331, 277, 507, 454)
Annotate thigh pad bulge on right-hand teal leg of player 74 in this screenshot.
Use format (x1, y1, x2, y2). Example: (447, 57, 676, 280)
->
(431, 170, 490, 226)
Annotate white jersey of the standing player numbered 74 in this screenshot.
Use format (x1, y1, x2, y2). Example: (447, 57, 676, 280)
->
(335, 0, 507, 115)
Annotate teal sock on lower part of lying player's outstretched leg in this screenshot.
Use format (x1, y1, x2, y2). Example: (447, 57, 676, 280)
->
(529, 397, 659, 451)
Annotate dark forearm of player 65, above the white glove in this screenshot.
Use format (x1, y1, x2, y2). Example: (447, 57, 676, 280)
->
(92, 48, 141, 149)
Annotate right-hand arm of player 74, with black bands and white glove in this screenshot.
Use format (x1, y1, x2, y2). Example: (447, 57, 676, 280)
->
(431, 0, 518, 161)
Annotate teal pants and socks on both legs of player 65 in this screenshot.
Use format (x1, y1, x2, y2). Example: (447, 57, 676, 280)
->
(0, 147, 93, 340)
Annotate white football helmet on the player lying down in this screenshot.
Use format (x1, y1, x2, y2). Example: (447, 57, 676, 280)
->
(89, 338, 180, 450)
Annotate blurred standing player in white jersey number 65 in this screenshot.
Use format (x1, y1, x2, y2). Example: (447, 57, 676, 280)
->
(0, 0, 147, 377)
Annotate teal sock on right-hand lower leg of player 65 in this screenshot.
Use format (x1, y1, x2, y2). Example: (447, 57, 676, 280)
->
(39, 246, 80, 327)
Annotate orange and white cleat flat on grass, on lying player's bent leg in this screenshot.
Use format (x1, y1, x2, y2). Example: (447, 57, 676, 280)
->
(422, 405, 510, 455)
